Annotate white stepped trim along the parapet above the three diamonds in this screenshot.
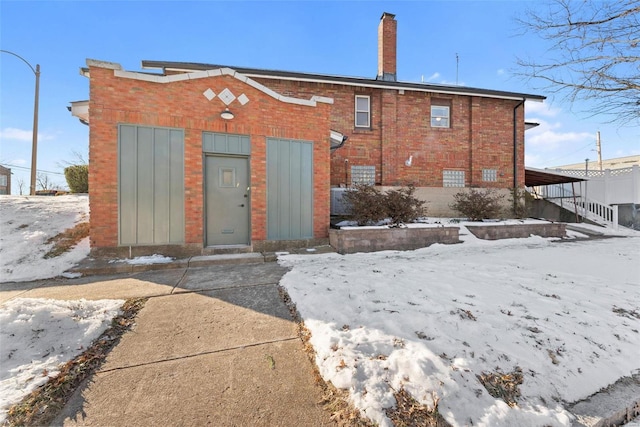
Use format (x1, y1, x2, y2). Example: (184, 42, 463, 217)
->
(87, 59, 333, 107)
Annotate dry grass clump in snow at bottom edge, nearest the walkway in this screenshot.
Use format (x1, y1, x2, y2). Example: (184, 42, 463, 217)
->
(385, 387, 451, 427)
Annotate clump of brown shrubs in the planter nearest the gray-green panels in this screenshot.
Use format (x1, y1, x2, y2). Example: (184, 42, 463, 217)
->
(343, 185, 426, 225)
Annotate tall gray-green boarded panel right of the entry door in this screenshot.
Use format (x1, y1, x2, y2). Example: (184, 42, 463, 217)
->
(267, 138, 313, 240)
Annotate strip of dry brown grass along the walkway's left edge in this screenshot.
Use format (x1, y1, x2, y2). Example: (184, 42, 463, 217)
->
(5, 298, 147, 426)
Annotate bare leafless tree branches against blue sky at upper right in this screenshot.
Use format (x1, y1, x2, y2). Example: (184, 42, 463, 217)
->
(518, 0, 640, 124)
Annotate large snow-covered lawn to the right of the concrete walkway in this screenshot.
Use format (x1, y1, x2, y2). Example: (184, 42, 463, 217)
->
(279, 223, 640, 426)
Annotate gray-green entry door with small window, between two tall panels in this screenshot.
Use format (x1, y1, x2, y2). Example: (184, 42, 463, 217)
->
(205, 156, 251, 246)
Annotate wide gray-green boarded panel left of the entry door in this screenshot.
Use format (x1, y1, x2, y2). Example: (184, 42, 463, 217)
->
(118, 125, 184, 246)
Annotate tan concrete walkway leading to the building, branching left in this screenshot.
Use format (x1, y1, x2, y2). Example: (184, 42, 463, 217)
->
(0, 262, 333, 426)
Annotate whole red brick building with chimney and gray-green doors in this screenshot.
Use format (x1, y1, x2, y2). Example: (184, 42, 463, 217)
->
(72, 13, 544, 253)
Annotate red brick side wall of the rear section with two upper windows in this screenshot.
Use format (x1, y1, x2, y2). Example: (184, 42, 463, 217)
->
(250, 78, 524, 188)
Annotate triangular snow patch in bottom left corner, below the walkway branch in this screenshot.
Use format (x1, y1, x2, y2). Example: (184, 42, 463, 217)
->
(0, 298, 124, 424)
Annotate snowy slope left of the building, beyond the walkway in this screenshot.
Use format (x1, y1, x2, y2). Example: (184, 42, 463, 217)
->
(0, 194, 89, 282)
